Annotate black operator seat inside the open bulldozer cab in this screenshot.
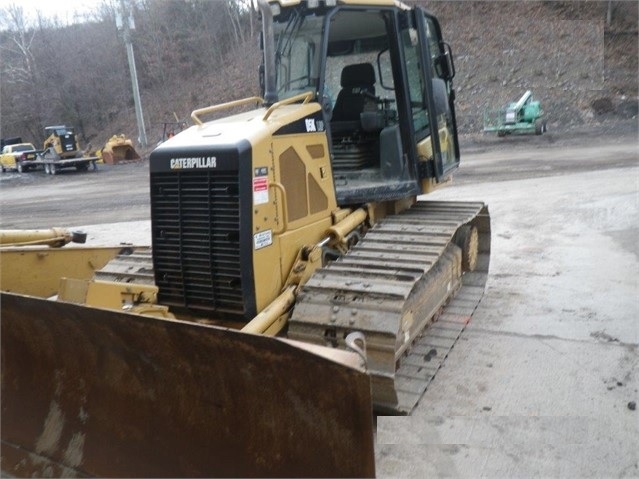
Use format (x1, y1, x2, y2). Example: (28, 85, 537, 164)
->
(331, 63, 375, 130)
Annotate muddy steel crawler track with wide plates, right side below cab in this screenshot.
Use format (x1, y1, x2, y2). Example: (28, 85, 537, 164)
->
(289, 201, 490, 414)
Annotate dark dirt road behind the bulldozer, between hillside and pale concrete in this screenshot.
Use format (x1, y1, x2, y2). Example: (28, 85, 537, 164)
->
(0, 125, 637, 229)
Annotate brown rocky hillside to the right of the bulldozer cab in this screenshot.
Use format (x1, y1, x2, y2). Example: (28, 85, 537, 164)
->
(426, 1, 639, 133)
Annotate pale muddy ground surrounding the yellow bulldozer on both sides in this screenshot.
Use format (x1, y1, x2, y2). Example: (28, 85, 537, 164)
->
(0, 120, 639, 478)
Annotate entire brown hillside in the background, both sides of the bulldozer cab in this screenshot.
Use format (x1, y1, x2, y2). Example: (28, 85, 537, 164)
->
(0, 0, 639, 151)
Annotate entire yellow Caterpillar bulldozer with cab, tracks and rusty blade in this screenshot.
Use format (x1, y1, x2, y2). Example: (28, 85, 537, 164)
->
(2, 0, 490, 477)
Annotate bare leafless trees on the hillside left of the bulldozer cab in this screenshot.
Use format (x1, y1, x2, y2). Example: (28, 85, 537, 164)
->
(0, 0, 259, 145)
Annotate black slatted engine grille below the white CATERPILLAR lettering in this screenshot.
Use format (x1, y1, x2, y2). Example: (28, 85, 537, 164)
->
(151, 170, 245, 316)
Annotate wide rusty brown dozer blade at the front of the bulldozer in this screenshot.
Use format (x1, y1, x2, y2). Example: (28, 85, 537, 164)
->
(0, 293, 375, 477)
